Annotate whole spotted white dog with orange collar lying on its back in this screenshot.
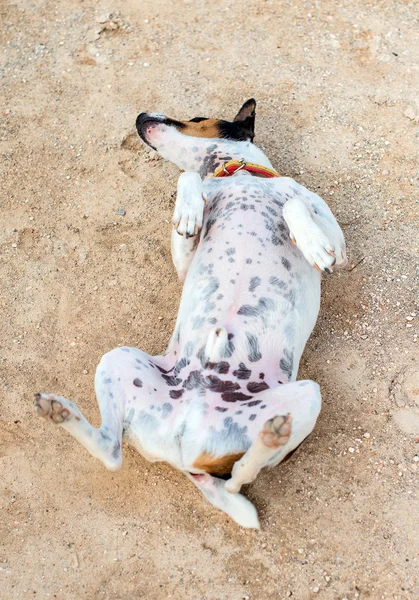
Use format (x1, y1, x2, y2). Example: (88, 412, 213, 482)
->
(35, 99, 346, 528)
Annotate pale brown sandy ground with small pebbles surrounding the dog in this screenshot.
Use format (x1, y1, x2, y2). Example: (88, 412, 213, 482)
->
(0, 0, 419, 600)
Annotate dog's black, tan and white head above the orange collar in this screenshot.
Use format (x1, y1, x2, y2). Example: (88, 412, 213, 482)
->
(136, 98, 269, 177)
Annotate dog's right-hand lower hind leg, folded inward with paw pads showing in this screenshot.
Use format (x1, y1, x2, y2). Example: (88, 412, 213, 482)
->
(225, 414, 292, 494)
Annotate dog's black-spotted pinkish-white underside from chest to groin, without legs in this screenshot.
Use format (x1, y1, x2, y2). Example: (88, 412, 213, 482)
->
(126, 177, 320, 471)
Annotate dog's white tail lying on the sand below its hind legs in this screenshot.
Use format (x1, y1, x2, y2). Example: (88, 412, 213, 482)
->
(185, 473, 260, 529)
